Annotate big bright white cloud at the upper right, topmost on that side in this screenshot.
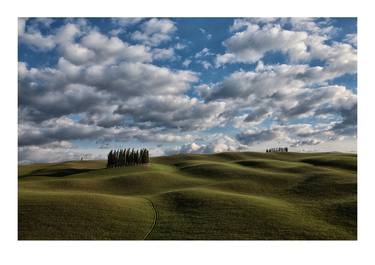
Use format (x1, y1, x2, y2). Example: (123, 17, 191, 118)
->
(216, 18, 357, 75)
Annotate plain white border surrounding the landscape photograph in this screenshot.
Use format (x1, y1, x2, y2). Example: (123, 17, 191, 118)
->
(0, 0, 375, 265)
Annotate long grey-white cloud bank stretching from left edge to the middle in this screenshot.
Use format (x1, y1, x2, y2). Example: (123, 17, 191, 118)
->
(19, 58, 197, 125)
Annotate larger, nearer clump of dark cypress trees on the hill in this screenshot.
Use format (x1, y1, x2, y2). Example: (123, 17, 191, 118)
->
(107, 148, 150, 168)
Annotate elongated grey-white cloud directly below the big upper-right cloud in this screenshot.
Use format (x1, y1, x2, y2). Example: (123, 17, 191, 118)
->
(200, 62, 346, 100)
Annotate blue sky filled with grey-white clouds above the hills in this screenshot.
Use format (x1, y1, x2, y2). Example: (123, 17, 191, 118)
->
(18, 18, 357, 164)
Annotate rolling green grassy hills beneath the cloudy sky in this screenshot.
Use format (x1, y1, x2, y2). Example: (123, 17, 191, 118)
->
(18, 152, 357, 240)
